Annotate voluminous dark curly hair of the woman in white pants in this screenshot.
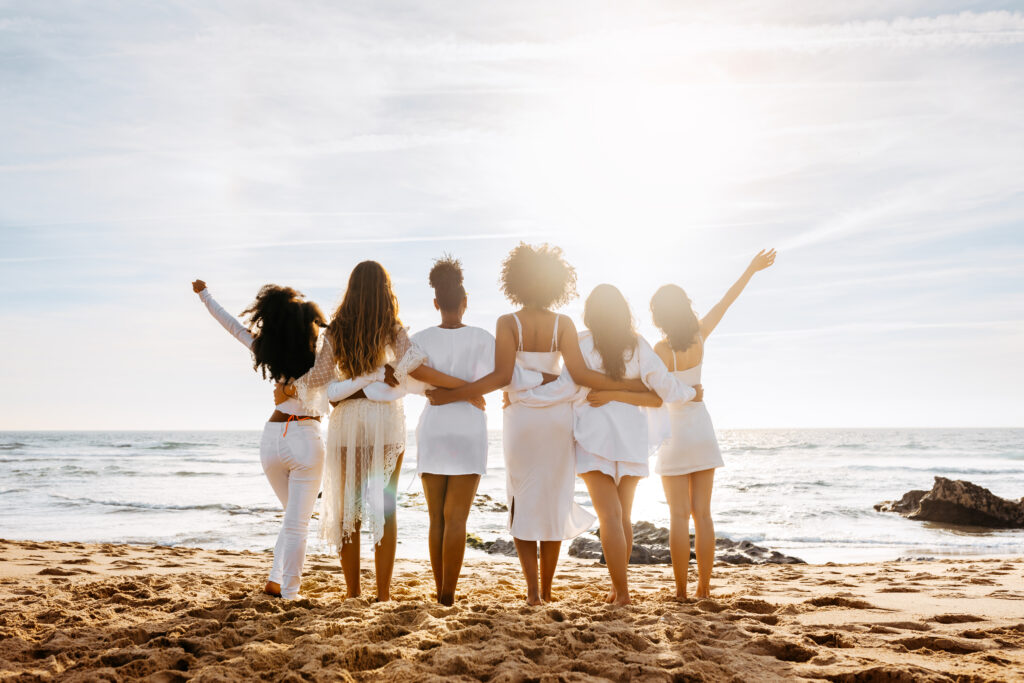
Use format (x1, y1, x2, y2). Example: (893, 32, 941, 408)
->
(242, 285, 327, 382)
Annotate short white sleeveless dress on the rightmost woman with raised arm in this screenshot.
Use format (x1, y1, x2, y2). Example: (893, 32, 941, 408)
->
(654, 344, 725, 476)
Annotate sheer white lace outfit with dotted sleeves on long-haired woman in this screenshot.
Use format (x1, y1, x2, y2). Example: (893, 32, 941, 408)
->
(295, 328, 424, 547)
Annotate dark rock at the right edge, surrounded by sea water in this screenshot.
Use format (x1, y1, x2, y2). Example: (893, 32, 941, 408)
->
(874, 477, 1024, 528)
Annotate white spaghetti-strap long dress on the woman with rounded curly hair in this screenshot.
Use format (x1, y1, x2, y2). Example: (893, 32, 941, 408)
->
(503, 313, 597, 541)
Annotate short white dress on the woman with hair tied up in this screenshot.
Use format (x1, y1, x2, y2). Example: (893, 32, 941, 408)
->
(413, 326, 495, 475)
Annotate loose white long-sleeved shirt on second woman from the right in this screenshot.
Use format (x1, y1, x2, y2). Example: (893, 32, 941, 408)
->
(517, 330, 696, 463)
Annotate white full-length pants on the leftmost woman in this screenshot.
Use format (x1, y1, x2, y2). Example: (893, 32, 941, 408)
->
(259, 420, 324, 600)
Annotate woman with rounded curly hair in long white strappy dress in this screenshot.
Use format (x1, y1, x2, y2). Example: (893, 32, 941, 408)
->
(427, 243, 646, 605)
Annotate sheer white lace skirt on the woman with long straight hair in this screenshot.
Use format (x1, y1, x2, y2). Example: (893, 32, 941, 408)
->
(319, 398, 406, 547)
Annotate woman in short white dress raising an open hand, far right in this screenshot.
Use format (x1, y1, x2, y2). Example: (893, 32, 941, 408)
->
(650, 249, 775, 599)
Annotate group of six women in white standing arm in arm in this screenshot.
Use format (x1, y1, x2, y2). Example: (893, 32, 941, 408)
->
(193, 244, 775, 604)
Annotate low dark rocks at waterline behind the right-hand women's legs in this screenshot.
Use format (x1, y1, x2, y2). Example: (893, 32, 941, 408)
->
(569, 521, 804, 564)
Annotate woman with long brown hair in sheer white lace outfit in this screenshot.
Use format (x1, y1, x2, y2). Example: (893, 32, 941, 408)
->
(278, 261, 424, 601)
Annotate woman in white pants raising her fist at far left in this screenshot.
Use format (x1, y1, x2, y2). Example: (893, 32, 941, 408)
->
(193, 280, 325, 600)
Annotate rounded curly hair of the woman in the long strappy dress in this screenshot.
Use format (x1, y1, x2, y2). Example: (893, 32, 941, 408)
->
(500, 242, 577, 308)
